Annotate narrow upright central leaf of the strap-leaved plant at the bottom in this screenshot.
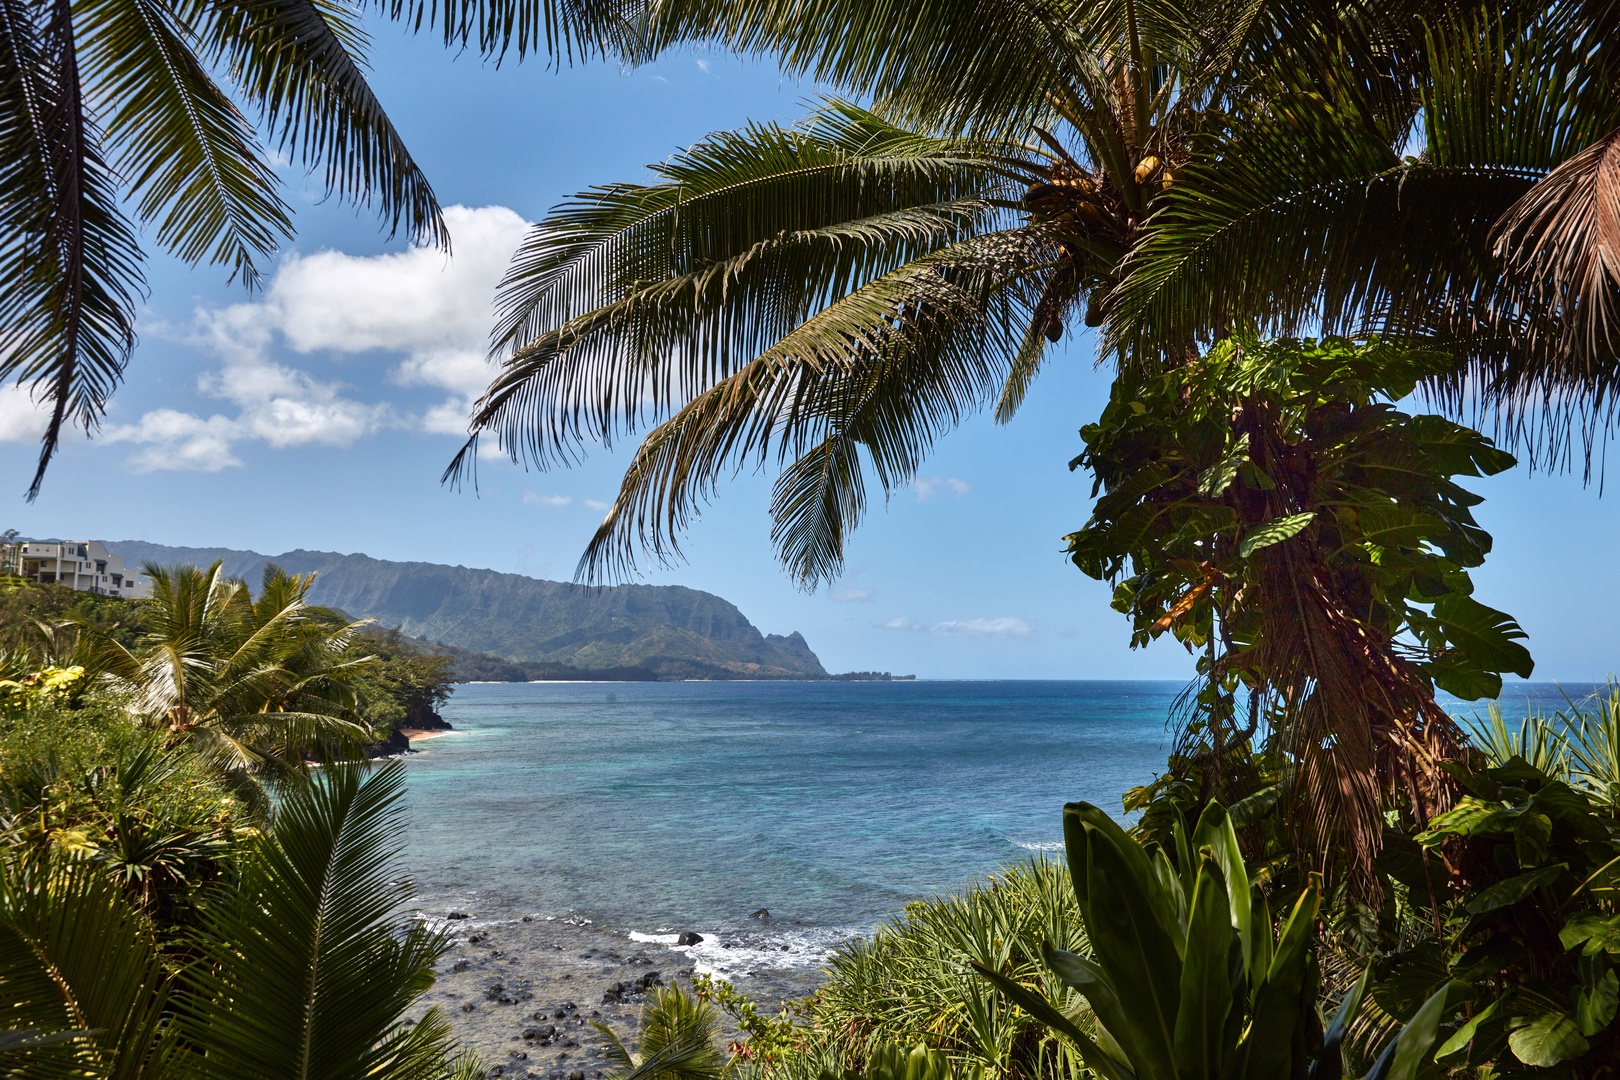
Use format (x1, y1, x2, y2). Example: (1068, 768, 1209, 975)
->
(1175, 855, 1247, 1080)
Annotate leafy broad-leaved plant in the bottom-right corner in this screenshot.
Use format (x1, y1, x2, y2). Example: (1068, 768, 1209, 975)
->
(1347, 758, 1620, 1077)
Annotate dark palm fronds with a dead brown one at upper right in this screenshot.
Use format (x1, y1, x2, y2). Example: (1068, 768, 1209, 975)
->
(1108, 0, 1620, 460)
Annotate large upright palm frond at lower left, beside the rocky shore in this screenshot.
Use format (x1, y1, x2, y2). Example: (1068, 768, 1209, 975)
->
(181, 763, 454, 1078)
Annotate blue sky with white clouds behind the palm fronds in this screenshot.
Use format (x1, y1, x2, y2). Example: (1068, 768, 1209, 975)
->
(0, 24, 1620, 682)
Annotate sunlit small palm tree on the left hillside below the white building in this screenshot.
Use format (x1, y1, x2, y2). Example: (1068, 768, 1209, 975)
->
(81, 562, 371, 797)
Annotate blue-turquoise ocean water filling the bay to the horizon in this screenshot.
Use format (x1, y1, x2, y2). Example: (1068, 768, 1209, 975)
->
(395, 682, 1591, 965)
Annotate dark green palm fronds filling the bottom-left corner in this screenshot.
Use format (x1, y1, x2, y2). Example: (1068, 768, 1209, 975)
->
(0, 763, 478, 1080)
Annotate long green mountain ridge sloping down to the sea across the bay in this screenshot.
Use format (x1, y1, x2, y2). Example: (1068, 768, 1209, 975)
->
(107, 541, 828, 678)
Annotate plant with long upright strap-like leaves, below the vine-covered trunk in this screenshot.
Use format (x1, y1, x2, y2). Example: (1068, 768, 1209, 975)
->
(975, 803, 1338, 1080)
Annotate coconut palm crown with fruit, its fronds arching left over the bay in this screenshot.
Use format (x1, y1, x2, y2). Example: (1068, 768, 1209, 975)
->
(446, 0, 1445, 586)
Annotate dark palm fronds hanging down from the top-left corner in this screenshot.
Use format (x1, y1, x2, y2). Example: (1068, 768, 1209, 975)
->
(0, 0, 617, 499)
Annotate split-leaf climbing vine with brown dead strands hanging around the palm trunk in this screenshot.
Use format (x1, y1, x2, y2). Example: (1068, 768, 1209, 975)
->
(1068, 335, 1533, 892)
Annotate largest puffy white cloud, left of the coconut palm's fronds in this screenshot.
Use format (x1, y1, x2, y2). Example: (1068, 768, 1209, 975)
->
(114, 206, 528, 470)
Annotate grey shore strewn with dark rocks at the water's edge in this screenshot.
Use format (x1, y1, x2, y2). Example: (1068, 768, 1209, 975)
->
(416, 912, 821, 1080)
